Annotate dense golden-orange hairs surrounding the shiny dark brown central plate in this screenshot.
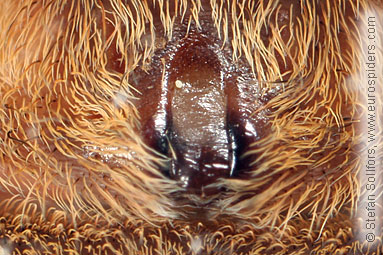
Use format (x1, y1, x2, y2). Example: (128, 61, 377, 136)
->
(0, 0, 383, 255)
